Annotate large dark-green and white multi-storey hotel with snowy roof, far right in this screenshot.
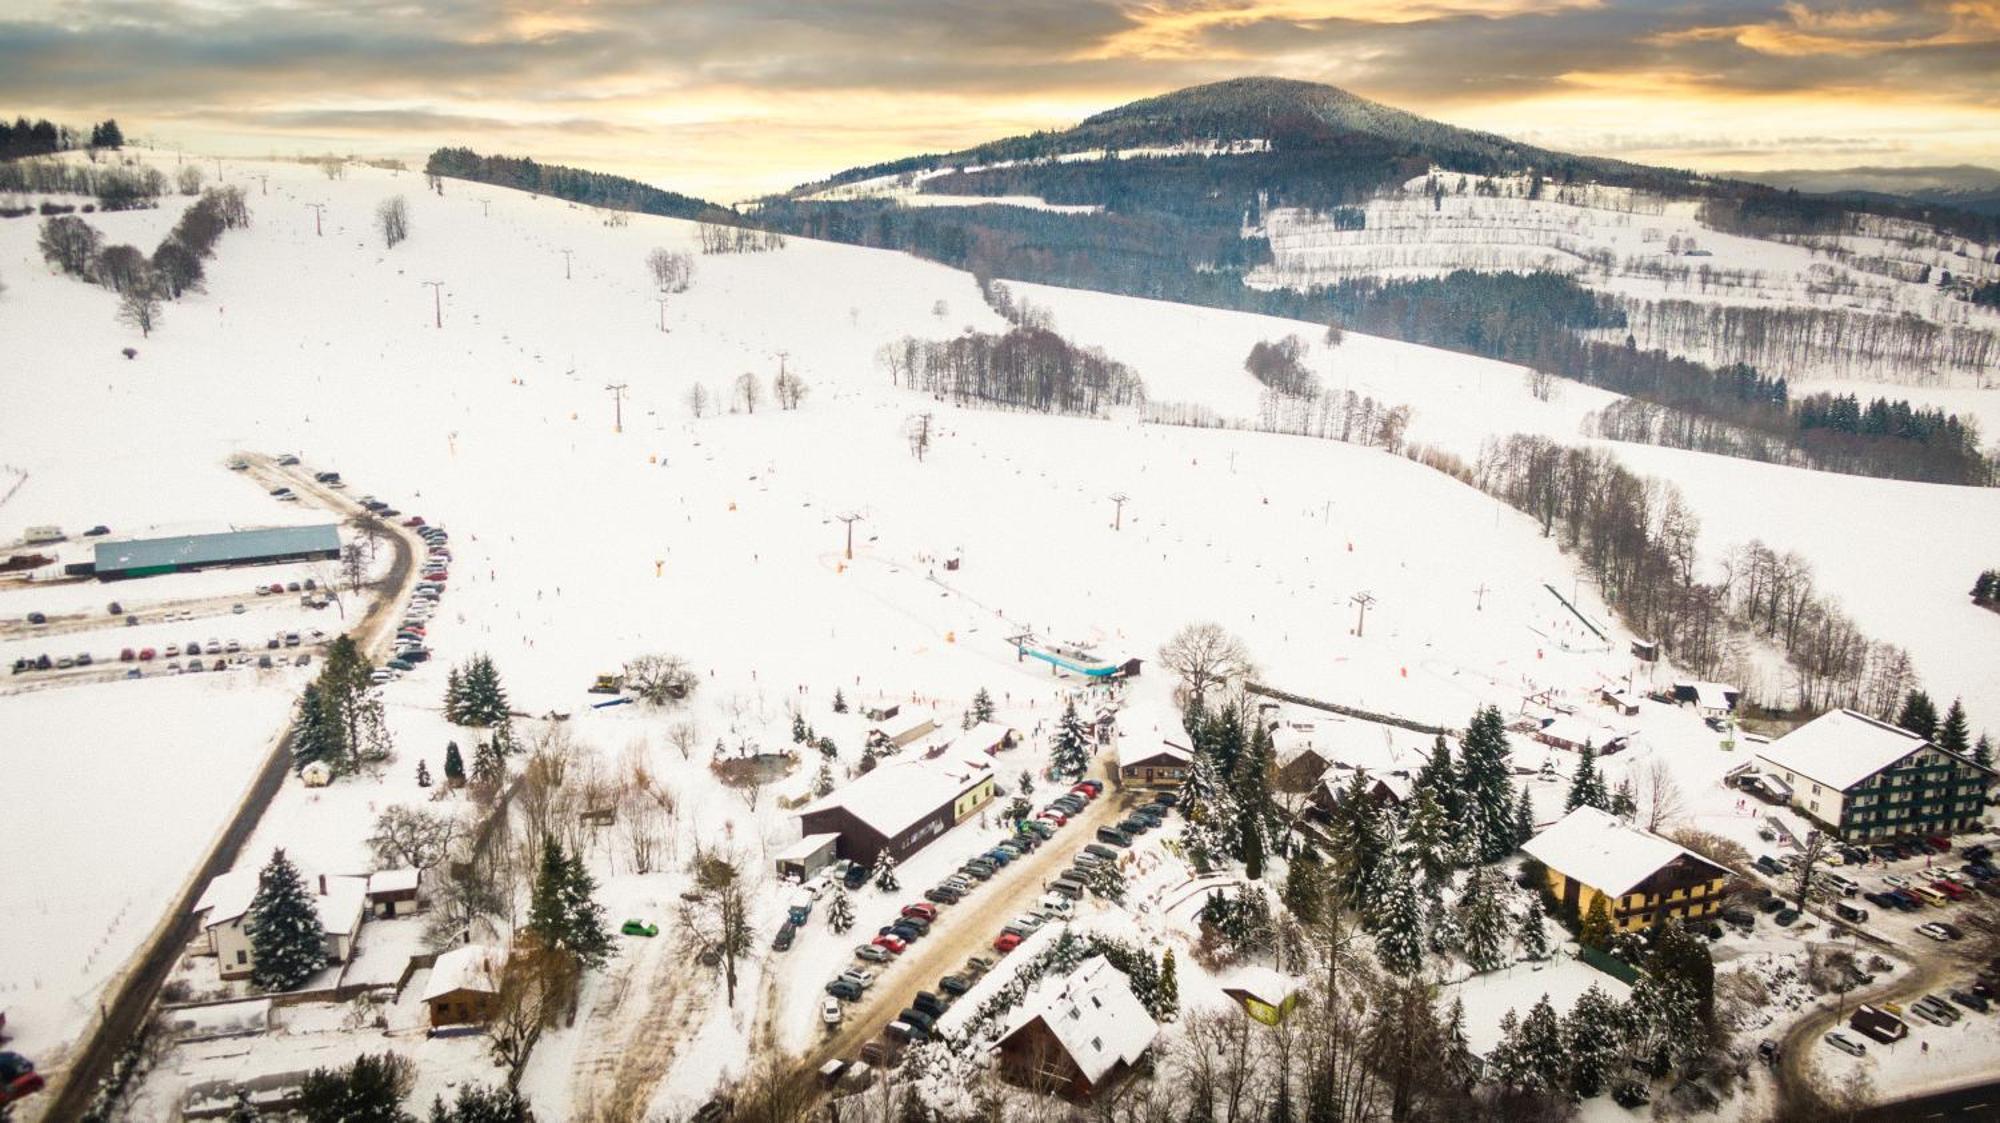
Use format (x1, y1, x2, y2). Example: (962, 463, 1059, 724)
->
(1758, 709, 1994, 841)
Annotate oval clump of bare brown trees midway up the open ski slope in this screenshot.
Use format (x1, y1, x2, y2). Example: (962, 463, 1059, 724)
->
(878, 328, 1146, 416)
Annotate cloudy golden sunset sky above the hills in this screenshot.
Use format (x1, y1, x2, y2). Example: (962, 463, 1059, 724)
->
(0, 0, 2000, 202)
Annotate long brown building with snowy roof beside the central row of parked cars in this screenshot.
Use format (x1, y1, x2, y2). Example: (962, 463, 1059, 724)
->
(798, 757, 994, 865)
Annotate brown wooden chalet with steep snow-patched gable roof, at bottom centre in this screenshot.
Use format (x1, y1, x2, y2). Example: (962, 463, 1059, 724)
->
(996, 955, 1160, 1099)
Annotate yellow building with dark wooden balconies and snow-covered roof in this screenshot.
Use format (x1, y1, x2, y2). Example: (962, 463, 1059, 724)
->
(1522, 807, 1730, 931)
